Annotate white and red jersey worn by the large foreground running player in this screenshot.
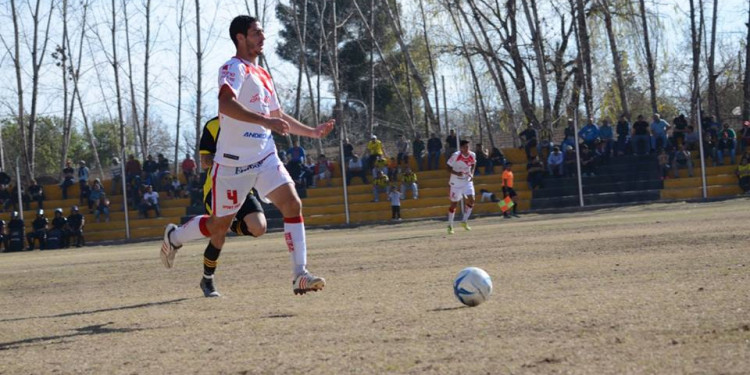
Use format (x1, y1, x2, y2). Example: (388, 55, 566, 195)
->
(214, 57, 281, 166)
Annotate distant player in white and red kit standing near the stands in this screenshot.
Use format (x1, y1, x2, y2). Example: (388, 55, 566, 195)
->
(448, 140, 477, 234)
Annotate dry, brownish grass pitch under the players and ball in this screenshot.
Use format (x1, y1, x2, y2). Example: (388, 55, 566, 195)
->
(0, 199, 750, 374)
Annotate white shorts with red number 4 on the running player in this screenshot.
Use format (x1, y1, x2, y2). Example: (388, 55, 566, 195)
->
(210, 152, 294, 217)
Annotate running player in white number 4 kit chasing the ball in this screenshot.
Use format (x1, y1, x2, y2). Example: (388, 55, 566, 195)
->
(161, 16, 334, 294)
